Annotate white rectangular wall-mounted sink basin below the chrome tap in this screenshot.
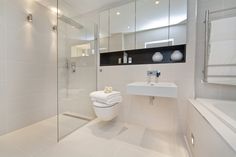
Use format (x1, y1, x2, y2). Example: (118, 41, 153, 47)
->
(127, 82, 177, 98)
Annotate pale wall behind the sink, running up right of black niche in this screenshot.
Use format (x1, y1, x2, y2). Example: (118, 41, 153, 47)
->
(98, 0, 196, 133)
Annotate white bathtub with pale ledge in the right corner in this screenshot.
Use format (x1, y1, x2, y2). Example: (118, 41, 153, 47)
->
(190, 98, 236, 151)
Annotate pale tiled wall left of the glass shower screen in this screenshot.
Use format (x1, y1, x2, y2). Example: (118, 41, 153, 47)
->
(0, 0, 57, 134)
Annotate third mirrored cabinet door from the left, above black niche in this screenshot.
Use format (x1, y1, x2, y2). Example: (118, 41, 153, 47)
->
(136, 0, 169, 49)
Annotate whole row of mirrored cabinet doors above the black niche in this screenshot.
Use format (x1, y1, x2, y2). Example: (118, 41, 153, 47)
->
(99, 0, 187, 53)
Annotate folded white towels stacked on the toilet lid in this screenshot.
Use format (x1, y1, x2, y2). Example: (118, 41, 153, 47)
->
(90, 91, 122, 105)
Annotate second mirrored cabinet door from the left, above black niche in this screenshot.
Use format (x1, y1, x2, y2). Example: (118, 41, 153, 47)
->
(109, 2, 135, 51)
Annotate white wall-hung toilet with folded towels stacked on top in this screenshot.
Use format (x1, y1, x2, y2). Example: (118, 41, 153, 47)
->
(90, 91, 122, 121)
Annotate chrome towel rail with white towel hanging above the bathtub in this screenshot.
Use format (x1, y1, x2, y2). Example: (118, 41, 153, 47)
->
(204, 9, 236, 85)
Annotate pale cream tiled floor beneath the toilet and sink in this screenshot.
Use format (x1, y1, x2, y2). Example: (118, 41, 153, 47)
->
(0, 117, 188, 157)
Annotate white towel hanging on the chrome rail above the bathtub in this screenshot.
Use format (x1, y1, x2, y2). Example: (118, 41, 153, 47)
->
(207, 17, 236, 84)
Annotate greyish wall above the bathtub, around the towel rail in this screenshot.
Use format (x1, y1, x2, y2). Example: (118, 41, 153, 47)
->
(195, 0, 236, 100)
